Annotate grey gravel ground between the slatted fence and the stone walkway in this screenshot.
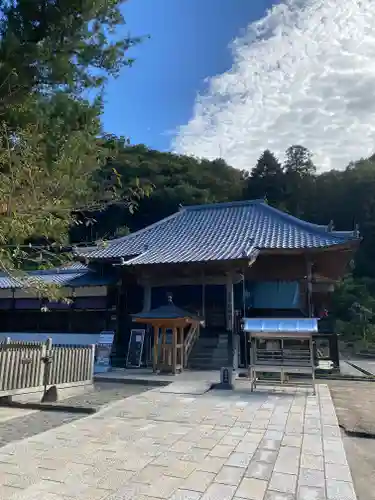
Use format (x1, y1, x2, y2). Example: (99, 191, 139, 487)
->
(0, 383, 151, 449)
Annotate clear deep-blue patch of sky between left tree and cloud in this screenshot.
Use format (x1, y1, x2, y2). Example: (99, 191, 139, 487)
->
(103, 0, 278, 150)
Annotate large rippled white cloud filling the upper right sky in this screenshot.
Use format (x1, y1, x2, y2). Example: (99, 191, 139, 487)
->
(173, 0, 375, 170)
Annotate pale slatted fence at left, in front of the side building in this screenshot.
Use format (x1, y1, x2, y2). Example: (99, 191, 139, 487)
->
(0, 338, 95, 396)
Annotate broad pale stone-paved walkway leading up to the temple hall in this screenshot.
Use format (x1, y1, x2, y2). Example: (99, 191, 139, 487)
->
(0, 383, 356, 500)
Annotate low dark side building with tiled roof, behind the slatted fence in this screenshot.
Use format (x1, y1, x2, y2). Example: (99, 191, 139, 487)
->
(0, 262, 118, 344)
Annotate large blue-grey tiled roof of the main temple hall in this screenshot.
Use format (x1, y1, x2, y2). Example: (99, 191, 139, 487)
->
(78, 200, 356, 265)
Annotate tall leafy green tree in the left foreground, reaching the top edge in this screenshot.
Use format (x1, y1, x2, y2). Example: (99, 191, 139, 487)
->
(0, 0, 144, 282)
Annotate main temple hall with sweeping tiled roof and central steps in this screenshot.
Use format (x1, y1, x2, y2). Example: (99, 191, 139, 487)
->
(77, 200, 360, 368)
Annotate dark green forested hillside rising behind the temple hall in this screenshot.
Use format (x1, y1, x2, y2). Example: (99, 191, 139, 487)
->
(72, 143, 375, 348)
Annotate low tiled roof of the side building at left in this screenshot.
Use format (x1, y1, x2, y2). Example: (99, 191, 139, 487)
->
(0, 263, 116, 289)
